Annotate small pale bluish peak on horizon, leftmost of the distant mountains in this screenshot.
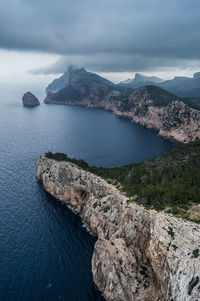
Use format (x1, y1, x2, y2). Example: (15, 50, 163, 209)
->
(119, 73, 163, 89)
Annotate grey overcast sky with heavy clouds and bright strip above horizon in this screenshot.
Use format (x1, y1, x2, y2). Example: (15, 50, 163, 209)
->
(0, 0, 200, 81)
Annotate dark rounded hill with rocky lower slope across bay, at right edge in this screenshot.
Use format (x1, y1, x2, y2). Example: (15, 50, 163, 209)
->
(115, 86, 200, 142)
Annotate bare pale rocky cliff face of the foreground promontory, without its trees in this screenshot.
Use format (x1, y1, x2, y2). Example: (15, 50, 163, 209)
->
(36, 155, 200, 301)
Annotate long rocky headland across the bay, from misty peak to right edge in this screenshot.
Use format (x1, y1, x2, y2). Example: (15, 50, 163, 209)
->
(45, 69, 200, 142)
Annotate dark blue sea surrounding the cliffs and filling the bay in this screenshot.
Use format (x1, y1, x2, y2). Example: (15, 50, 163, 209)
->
(0, 84, 172, 301)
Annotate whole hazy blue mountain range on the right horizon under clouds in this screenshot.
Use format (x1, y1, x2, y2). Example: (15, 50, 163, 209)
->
(119, 72, 200, 97)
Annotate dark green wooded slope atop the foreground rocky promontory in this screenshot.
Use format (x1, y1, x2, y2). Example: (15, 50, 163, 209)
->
(46, 140, 200, 222)
